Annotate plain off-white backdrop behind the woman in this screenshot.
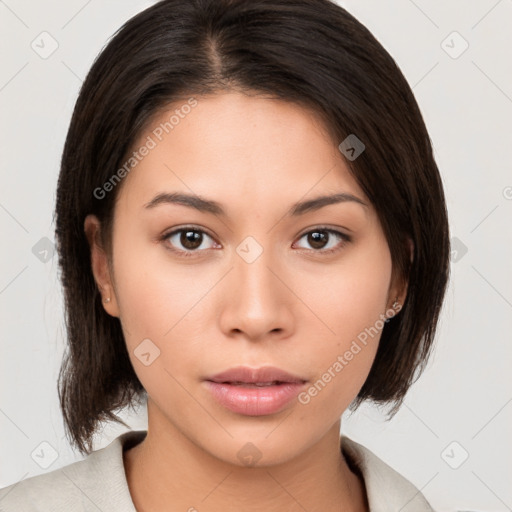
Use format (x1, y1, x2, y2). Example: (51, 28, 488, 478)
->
(0, 0, 512, 511)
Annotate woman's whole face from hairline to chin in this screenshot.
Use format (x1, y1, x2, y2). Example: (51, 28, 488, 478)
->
(85, 93, 402, 464)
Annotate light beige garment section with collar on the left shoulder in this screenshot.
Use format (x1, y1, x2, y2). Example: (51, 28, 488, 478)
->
(0, 431, 145, 512)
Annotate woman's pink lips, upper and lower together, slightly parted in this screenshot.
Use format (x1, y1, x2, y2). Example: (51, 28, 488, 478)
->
(204, 366, 307, 416)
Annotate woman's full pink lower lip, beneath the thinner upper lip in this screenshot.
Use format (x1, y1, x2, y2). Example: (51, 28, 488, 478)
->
(205, 380, 305, 416)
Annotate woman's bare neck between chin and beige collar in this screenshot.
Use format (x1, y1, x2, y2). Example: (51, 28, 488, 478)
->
(124, 412, 368, 512)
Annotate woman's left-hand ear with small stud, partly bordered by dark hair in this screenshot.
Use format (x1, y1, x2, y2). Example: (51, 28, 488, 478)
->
(84, 215, 119, 317)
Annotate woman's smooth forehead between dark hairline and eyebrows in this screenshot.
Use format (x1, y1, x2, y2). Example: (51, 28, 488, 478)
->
(114, 93, 369, 210)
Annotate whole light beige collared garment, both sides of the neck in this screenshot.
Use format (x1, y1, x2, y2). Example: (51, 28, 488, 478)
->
(0, 430, 433, 512)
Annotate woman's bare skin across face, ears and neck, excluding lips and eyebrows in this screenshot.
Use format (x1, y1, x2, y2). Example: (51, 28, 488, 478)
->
(84, 92, 406, 512)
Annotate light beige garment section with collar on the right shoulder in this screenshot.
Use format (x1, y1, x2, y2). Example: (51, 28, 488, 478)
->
(341, 436, 433, 512)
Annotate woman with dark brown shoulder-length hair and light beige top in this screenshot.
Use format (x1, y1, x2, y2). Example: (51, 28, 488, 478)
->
(0, 0, 449, 512)
